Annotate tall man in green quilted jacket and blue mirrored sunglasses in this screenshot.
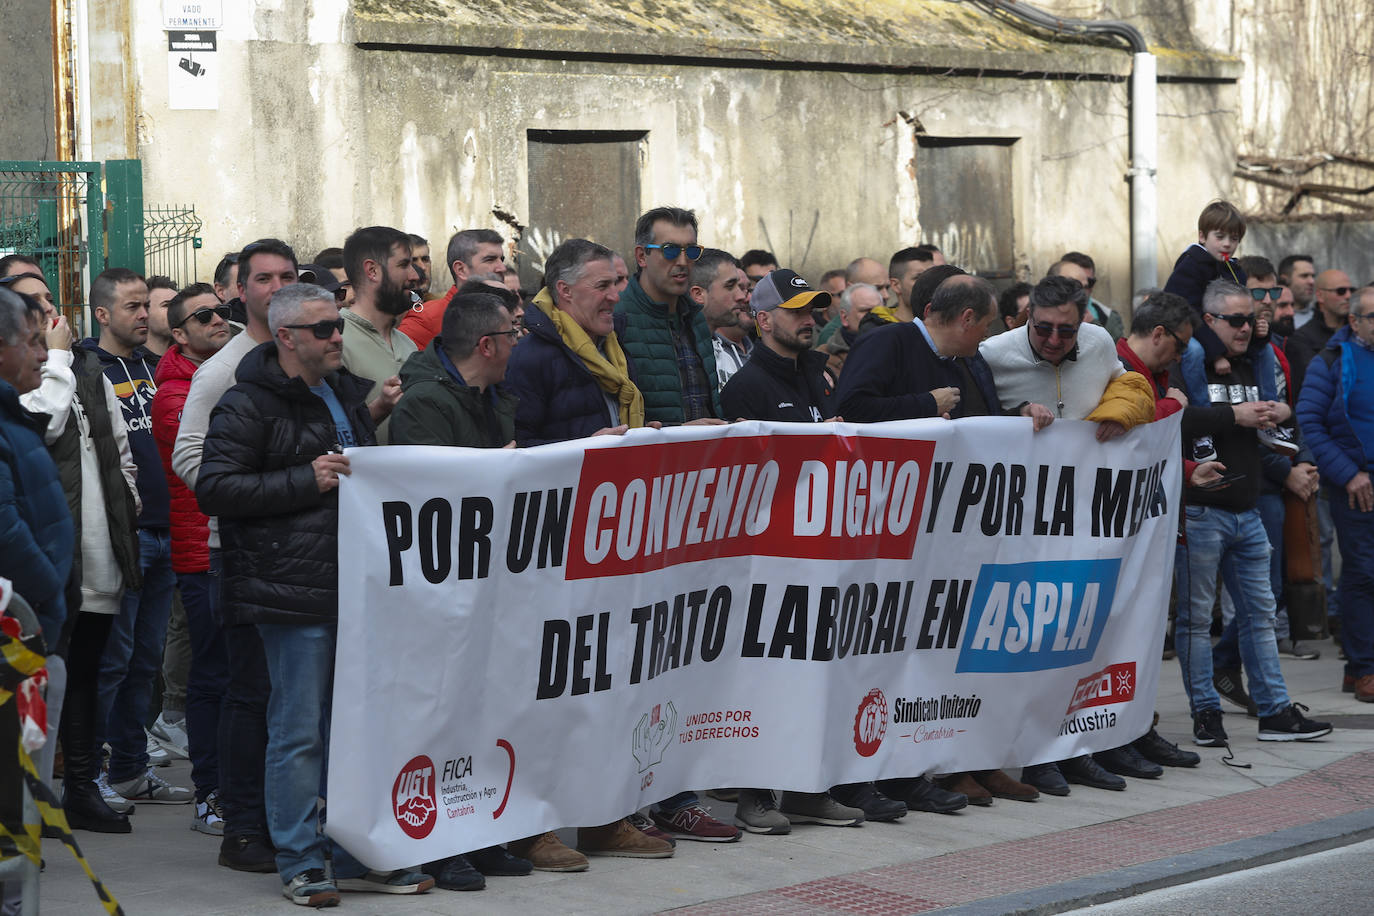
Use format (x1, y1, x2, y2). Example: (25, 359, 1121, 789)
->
(616, 207, 720, 426)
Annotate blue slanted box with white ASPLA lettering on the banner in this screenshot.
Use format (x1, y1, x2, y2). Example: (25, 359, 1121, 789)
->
(955, 559, 1121, 673)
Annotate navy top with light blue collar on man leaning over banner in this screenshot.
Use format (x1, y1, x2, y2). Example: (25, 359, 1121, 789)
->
(837, 321, 1002, 423)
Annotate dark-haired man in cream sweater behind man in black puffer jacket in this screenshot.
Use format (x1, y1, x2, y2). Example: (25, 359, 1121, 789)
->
(172, 233, 300, 872)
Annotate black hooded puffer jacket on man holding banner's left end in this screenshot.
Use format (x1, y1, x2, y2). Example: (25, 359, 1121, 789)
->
(195, 341, 376, 626)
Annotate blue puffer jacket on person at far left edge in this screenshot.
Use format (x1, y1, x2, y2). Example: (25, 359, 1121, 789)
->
(0, 380, 76, 651)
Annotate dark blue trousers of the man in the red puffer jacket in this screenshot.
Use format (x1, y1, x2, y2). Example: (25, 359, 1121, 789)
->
(177, 573, 229, 802)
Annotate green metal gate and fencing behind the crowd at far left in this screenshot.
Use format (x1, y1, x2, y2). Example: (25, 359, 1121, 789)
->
(0, 159, 202, 332)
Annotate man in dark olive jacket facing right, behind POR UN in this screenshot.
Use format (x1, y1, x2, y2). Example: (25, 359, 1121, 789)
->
(392, 293, 519, 449)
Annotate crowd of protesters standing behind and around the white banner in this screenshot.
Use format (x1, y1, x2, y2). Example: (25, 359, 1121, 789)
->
(0, 202, 1374, 906)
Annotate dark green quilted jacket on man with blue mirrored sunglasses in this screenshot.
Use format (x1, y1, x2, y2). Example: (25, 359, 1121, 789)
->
(616, 277, 721, 426)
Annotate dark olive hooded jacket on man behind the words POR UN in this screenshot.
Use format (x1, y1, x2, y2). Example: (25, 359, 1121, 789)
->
(392, 338, 515, 449)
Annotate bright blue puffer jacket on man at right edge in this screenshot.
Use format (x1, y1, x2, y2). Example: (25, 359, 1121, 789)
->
(1297, 325, 1370, 488)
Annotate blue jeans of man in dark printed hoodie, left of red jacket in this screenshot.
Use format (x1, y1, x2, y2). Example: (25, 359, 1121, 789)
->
(96, 527, 176, 783)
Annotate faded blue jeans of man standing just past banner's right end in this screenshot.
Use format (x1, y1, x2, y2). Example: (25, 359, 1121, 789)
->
(1173, 505, 1289, 717)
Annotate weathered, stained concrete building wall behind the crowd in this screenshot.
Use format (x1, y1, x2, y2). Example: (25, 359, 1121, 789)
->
(112, 0, 1235, 311)
